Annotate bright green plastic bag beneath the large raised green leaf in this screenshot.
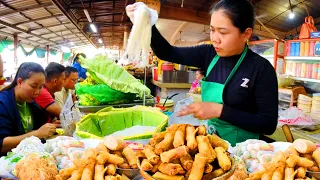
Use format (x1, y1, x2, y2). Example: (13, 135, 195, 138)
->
(76, 83, 136, 106)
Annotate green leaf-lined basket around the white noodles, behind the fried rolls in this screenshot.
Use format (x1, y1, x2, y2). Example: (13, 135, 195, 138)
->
(76, 106, 168, 140)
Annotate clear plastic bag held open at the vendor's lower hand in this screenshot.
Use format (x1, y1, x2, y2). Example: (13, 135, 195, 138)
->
(169, 96, 208, 129)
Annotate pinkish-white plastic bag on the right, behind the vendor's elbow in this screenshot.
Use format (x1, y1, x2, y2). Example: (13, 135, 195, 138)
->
(278, 107, 319, 130)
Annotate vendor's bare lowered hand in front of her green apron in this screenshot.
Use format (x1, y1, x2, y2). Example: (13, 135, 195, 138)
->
(178, 102, 223, 120)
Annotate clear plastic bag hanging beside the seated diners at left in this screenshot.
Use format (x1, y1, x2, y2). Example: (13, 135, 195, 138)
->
(60, 93, 81, 136)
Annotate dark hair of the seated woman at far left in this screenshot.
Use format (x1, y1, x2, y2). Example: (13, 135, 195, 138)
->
(2, 62, 45, 91)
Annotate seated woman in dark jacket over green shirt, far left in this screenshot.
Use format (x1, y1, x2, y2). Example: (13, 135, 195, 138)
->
(0, 62, 56, 156)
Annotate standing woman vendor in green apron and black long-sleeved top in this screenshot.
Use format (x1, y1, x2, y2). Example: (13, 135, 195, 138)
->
(126, 0, 278, 145)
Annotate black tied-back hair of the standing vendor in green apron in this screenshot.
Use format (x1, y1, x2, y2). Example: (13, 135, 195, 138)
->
(210, 0, 255, 33)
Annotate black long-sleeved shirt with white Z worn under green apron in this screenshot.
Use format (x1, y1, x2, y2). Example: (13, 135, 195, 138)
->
(151, 26, 278, 135)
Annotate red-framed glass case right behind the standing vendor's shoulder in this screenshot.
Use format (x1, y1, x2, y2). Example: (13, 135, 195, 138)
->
(249, 39, 285, 74)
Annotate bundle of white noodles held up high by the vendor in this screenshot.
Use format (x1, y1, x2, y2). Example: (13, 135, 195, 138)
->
(120, 2, 158, 68)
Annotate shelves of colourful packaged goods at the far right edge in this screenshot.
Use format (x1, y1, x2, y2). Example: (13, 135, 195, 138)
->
(284, 38, 320, 83)
